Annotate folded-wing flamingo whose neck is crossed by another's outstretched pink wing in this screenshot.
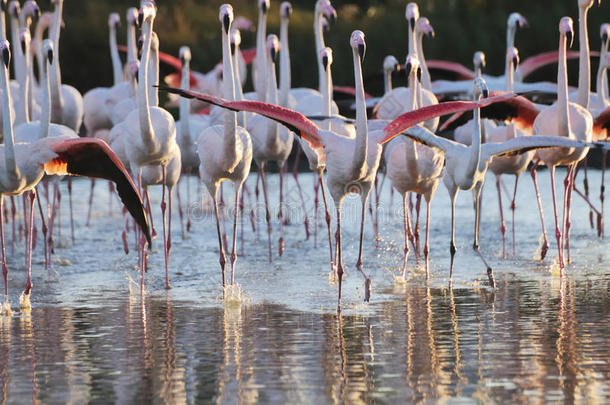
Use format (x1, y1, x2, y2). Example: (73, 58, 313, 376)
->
(197, 4, 249, 289)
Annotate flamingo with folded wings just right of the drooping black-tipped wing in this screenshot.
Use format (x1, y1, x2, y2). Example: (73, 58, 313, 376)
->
(120, 1, 178, 294)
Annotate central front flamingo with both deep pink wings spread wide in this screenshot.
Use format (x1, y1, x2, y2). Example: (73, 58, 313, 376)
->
(163, 34, 524, 311)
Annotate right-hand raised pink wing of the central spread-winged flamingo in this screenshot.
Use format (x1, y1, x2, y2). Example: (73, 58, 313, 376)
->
(381, 93, 515, 143)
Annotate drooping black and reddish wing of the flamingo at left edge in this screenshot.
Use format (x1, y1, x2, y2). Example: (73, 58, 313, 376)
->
(44, 138, 151, 246)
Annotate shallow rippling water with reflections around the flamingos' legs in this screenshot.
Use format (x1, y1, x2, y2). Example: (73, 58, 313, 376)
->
(0, 167, 610, 404)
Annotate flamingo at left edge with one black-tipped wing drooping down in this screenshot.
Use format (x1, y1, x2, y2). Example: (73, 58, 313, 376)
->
(0, 40, 150, 312)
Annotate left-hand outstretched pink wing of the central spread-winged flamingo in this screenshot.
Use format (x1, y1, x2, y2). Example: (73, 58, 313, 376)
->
(159, 86, 322, 149)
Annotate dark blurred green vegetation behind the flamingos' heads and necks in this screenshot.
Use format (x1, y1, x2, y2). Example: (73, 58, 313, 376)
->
(53, 0, 610, 94)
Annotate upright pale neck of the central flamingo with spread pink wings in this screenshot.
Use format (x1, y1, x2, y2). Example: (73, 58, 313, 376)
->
(352, 49, 369, 178)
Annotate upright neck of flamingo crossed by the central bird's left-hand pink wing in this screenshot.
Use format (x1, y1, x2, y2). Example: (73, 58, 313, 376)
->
(222, 27, 236, 163)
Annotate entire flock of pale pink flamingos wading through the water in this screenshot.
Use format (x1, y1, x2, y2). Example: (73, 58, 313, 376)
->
(0, 0, 610, 314)
